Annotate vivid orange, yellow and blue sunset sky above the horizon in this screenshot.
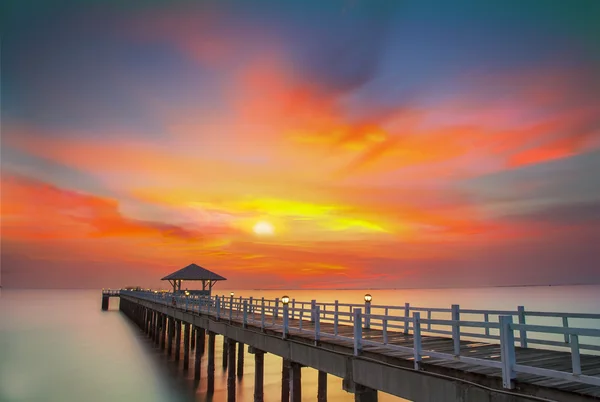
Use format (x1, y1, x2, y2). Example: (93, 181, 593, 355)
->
(0, 0, 600, 289)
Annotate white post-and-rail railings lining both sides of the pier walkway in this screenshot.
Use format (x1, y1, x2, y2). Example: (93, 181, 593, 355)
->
(121, 291, 600, 388)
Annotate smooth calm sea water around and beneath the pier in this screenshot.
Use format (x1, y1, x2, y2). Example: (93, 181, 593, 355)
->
(0, 286, 600, 402)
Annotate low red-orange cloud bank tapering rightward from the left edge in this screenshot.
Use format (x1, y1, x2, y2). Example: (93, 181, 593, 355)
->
(1, 174, 232, 242)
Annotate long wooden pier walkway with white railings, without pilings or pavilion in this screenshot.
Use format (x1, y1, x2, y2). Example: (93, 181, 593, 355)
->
(113, 292, 600, 401)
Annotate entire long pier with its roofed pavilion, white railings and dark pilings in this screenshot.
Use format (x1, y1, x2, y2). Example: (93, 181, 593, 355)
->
(102, 264, 600, 402)
